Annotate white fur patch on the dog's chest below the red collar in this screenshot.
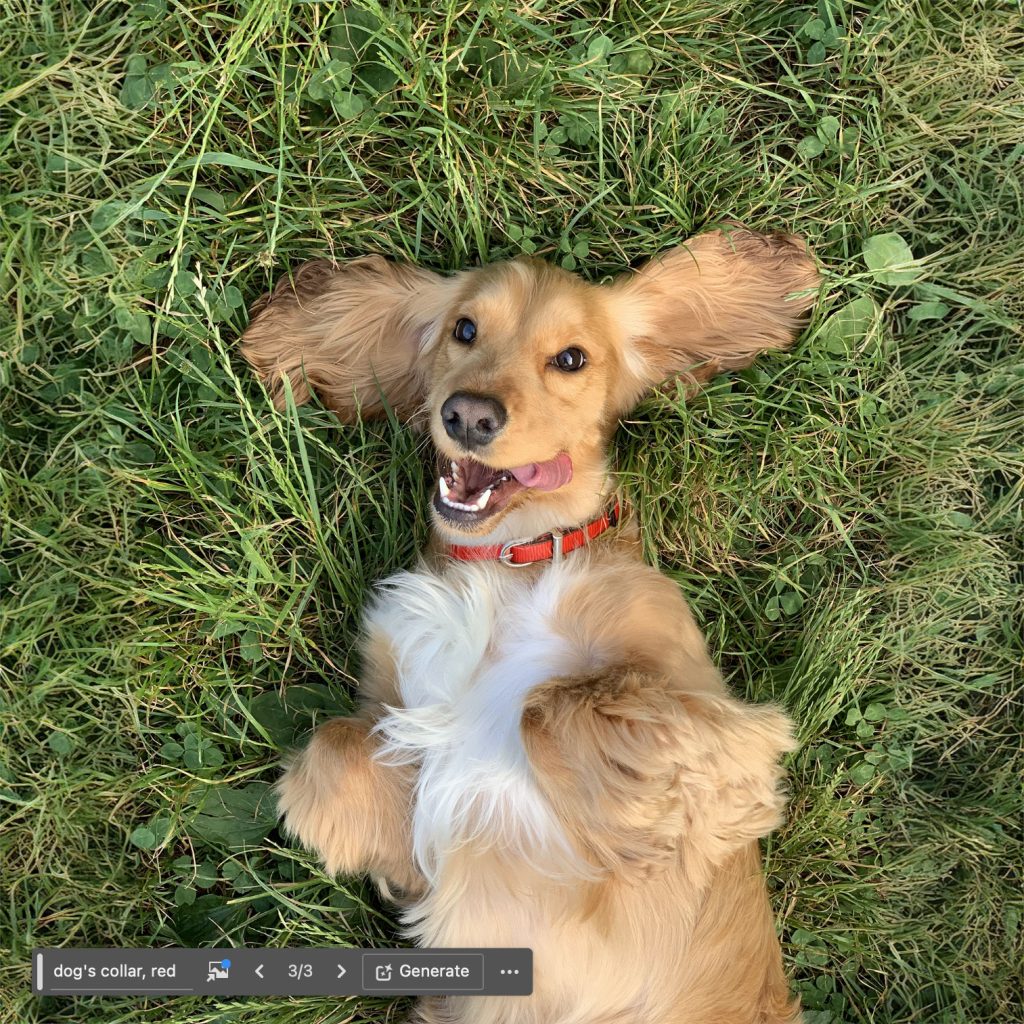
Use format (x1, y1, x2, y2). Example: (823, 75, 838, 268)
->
(368, 564, 594, 880)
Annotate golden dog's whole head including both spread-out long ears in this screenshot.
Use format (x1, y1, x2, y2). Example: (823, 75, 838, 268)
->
(237, 228, 818, 537)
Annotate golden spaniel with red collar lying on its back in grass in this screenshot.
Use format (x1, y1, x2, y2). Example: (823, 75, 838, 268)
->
(243, 226, 818, 1024)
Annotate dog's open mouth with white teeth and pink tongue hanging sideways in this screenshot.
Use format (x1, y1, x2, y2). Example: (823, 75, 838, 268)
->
(434, 452, 572, 526)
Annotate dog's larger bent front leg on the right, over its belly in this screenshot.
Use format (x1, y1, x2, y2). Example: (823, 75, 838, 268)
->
(521, 668, 794, 876)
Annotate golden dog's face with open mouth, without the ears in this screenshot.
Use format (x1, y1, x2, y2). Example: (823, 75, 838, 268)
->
(426, 260, 627, 534)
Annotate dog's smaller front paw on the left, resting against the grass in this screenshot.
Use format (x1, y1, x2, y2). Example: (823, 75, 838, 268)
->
(278, 717, 423, 894)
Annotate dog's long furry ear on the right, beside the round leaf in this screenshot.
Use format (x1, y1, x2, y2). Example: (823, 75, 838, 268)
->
(609, 227, 819, 412)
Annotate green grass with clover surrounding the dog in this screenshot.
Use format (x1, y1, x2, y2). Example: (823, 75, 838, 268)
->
(0, 0, 1024, 1024)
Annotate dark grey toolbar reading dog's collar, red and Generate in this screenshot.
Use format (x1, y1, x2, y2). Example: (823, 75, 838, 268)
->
(32, 948, 534, 996)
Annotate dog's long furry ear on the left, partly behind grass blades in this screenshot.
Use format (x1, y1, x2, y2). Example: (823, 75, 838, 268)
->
(242, 256, 456, 422)
